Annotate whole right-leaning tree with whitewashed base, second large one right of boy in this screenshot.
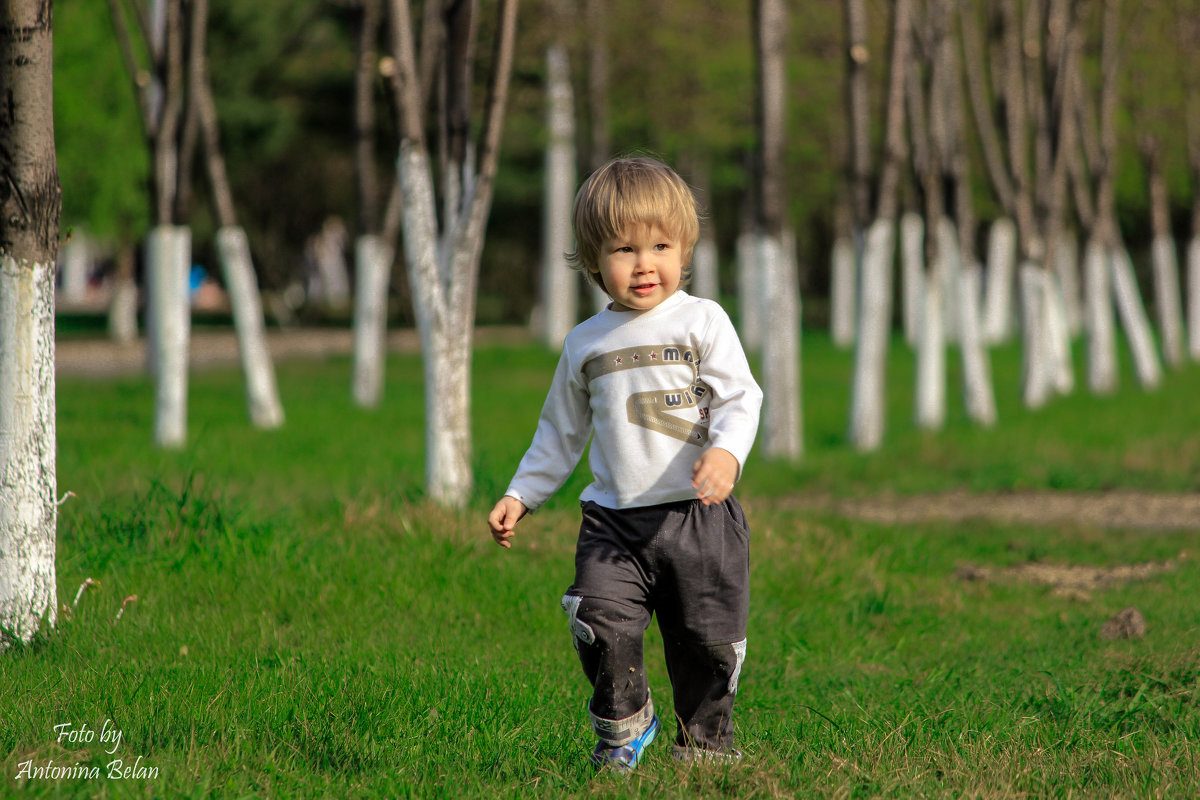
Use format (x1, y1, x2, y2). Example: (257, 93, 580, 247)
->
(848, 0, 912, 452)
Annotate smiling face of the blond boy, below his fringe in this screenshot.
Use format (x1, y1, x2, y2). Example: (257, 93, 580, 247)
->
(593, 225, 683, 311)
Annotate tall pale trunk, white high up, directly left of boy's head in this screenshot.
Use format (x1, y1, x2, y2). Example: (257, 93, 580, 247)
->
(541, 42, 580, 349)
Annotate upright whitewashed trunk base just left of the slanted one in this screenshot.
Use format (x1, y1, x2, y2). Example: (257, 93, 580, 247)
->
(146, 225, 192, 447)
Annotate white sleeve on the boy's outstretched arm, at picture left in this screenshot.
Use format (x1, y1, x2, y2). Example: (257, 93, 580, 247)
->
(505, 349, 592, 511)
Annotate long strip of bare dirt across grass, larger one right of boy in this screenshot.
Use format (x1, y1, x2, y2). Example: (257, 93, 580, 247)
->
(773, 489, 1200, 531)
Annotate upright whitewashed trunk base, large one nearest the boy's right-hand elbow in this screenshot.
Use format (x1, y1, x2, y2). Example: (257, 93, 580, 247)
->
(758, 235, 804, 459)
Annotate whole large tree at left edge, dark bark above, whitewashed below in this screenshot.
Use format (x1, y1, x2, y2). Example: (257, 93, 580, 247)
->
(0, 0, 62, 649)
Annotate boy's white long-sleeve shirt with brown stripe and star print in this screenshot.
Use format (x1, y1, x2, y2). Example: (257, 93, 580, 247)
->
(505, 290, 762, 511)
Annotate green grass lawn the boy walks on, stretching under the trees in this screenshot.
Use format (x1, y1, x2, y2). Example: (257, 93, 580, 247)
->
(0, 335, 1200, 799)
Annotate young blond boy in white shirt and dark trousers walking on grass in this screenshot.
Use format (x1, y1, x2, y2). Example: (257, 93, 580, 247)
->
(487, 158, 762, 771)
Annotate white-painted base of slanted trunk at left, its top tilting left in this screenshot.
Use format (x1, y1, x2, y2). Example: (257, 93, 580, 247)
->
(216, 225, 283, 429)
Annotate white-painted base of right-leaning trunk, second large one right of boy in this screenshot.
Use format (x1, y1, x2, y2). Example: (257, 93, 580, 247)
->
(847, 218, 895, 452)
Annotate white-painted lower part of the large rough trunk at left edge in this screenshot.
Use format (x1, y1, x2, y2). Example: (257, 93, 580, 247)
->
(0, 254, 59, 649)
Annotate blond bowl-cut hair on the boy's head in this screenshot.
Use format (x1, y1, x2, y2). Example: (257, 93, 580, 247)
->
(566, 157, 700, 289)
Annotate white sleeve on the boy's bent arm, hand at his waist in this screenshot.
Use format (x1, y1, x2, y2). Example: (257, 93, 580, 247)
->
(700, 308, 762, 474)
